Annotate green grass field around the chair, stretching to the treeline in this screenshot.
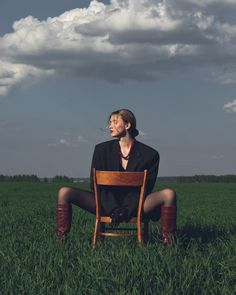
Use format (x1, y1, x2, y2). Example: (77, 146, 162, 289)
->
(0, 182, 236, 295)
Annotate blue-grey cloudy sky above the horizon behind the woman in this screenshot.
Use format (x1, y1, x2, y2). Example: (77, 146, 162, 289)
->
(0, 0, 236, 177)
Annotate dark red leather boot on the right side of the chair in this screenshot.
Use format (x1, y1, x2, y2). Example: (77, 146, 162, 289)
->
(161, 206, 177, 245)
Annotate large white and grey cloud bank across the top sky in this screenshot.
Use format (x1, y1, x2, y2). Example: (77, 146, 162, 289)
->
(0, 0, 236, 95)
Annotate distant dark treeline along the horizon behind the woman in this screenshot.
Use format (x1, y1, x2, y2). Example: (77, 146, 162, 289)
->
(0, 174, 236, 183)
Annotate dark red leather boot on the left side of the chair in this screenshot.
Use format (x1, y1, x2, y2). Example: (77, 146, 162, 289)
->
(56, 204, 72, 241)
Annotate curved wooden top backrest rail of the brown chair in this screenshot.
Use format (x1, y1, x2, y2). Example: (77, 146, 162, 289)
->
(94, 169, 147, 186)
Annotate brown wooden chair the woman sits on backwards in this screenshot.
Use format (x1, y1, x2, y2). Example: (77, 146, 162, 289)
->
(93, 169, 148, 248)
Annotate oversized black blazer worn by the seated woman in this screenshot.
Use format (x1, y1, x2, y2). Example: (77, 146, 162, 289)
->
(90, 140, 159, 217)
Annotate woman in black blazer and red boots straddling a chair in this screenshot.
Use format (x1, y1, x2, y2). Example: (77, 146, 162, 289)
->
(56, 109, 176, 244)
